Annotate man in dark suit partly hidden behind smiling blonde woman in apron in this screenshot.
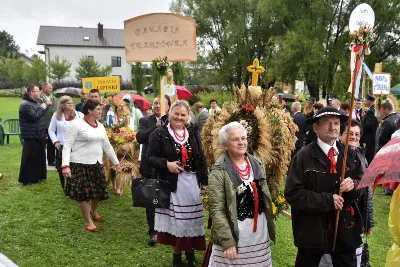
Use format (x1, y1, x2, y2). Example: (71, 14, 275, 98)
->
(136, 96, 171, 246)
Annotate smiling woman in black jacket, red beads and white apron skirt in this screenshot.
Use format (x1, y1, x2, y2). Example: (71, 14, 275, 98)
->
(147, 101, 208, 266)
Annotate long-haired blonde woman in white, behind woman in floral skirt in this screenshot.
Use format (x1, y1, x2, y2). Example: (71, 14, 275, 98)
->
(49, 96, 83, 193)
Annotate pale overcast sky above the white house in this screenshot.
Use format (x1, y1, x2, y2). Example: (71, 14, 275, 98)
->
(0, 0, 172, 55)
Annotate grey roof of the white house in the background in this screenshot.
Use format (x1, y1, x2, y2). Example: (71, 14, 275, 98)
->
(36, 26, 125, 48)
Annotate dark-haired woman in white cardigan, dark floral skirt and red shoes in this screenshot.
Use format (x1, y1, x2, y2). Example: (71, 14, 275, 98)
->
(61, 99, 121, 232)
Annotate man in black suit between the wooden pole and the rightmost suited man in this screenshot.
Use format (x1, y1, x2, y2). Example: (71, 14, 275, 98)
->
(360, 94, 379, 164)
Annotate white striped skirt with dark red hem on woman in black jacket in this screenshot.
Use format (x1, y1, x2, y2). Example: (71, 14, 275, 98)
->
(154, 172, 206, 251)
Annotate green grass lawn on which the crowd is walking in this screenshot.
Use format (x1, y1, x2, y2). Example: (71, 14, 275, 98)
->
(0, 98, 392, 267)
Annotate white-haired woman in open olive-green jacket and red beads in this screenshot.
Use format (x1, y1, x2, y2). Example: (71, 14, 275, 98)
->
(209, 122, 275, 267)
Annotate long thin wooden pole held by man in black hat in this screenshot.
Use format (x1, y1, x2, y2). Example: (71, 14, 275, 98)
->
(332, 45, 368, 251)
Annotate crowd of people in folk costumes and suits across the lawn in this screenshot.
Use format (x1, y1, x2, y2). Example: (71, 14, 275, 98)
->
(19, 83, 400, 267)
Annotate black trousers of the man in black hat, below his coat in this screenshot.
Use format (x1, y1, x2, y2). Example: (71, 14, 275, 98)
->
(295, 248, 357, 267)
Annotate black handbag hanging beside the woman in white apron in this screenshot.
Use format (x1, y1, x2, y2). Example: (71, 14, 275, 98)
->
(132, 178, 171, 209)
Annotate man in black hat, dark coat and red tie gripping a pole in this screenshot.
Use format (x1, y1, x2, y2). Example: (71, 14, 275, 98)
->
(285, 107, 362, 267)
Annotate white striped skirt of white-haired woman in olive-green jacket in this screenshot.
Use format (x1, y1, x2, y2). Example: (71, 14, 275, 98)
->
(208, 216, 272, 267)
